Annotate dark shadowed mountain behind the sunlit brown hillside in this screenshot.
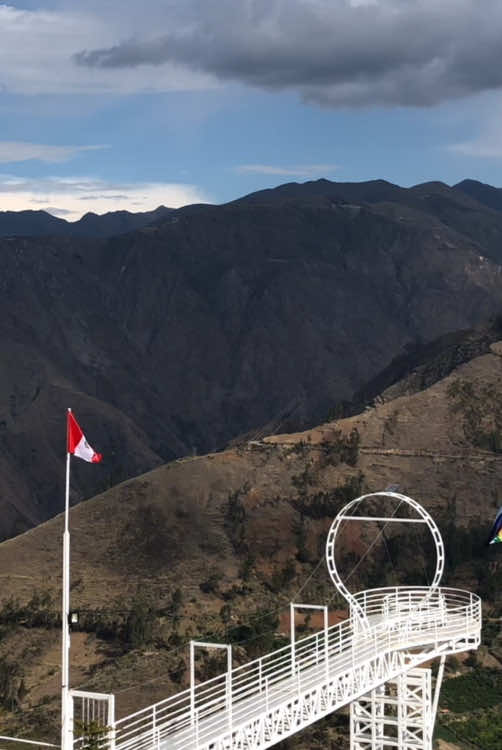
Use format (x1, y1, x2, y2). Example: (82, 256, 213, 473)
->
(0, 180, 502, 538)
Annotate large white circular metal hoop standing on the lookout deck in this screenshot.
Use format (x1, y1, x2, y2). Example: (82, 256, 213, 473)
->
(326, 492, 444, 619)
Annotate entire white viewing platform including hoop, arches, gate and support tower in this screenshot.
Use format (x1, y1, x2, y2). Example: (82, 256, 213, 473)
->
(30, 492, 481, 750)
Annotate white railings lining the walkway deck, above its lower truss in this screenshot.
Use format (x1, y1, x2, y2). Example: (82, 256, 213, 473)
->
(111, 586, 481, 750)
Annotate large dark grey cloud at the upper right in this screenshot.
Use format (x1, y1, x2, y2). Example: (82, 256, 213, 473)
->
(74, 0, 502, 107)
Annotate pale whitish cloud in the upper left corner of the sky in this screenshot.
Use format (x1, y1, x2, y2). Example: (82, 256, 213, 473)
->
(0, 0, 216, 95)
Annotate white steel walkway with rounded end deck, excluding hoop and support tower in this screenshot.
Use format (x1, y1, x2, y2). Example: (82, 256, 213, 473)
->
(110, 587, 481, 750)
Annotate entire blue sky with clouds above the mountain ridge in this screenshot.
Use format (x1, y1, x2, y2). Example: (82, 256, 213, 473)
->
(0, 0, 502, 221)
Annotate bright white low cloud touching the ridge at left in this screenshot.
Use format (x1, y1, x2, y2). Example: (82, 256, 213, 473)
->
(0, 174, 208, 220)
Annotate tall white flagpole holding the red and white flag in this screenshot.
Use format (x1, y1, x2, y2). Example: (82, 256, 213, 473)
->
(61, 409, 71, 750)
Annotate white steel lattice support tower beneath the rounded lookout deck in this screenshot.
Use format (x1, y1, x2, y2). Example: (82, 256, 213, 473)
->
(350, 667, 432, 750)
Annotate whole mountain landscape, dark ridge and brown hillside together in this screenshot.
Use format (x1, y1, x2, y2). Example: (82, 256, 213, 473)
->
(0, 180, 502, 749)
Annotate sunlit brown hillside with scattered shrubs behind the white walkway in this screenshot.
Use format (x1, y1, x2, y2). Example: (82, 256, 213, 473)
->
(0, 342, 502, 747)
